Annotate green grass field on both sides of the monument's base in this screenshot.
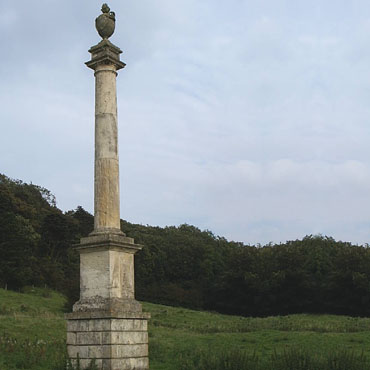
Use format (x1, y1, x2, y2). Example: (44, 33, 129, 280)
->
(0, 289, 370, 370)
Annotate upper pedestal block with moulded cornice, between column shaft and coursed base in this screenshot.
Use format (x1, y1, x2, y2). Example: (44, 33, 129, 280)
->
(73, 233, 142, 312)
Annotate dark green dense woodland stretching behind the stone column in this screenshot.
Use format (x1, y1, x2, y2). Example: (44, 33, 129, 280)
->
(0, 174, 370, 316)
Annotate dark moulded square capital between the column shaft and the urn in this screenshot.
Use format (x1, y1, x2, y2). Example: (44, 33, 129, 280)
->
(85, 40, 126, 71)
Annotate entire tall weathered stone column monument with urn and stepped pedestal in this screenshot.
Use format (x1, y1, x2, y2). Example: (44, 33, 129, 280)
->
(66, 4, 150, 370)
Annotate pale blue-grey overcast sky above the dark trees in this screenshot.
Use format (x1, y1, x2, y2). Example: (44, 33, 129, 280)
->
(0, 0, 370, 244)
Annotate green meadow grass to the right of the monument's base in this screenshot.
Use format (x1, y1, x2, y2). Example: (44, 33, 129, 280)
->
(144, 303, 370, 370)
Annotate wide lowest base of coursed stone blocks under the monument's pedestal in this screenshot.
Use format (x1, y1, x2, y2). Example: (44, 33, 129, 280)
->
(66, 311, 150, 370)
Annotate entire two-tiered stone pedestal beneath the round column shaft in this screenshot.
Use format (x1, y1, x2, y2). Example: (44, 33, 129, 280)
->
(66, 232, 150, 370)
